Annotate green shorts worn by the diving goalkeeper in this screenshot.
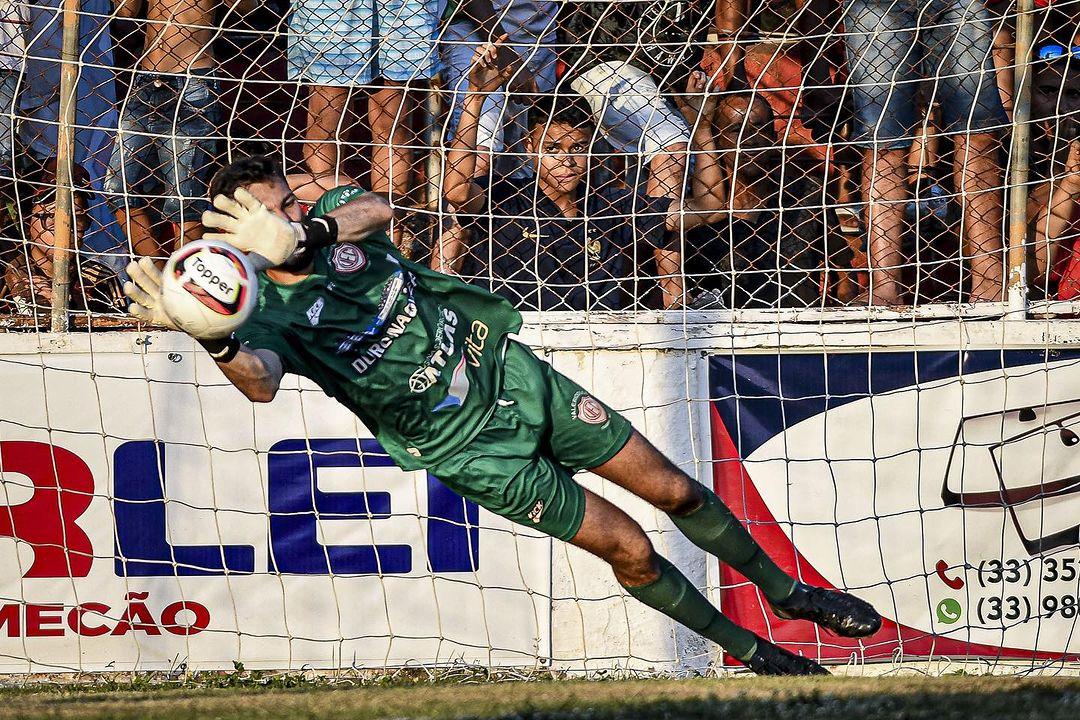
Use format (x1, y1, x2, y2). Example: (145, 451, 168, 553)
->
(430, 341, 633, 540)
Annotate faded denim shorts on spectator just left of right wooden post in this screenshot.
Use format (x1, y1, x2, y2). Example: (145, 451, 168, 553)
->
(843, 0, 1009, 149)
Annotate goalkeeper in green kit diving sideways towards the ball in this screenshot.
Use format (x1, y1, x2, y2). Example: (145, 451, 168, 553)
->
(124, 166, 881, 675)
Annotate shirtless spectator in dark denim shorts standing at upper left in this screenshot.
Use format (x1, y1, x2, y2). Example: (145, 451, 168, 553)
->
(105, 0, 254, 257)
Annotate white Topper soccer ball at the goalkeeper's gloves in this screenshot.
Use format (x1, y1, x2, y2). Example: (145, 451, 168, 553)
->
(161, 240, 259, 340)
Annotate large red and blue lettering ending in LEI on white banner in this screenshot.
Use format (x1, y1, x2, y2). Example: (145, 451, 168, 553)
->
(0, 438, 480, 580)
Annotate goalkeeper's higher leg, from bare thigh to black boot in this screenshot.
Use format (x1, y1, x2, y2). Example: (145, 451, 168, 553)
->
(592, 432, 881, 637)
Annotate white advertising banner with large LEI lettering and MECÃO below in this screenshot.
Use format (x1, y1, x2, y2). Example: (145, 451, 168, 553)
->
(0, 343, 551, 673)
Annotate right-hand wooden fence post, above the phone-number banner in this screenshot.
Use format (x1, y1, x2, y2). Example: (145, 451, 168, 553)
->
(1005, 0, 1035, 317)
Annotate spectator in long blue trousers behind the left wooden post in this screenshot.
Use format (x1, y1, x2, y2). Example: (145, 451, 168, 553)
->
(15, 0, 127, 268)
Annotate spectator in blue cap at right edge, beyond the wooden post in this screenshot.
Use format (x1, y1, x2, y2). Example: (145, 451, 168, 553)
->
(1027, 43, 1080, 300)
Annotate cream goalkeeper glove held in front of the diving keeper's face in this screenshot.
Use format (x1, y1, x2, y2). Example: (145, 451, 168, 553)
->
(203, 188, 305, 270)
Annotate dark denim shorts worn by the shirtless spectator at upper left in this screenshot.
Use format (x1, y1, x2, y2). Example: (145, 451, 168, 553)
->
(105, 70, 221, 222)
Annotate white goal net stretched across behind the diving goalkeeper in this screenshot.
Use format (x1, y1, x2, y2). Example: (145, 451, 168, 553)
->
(0, 0, 1080, 674)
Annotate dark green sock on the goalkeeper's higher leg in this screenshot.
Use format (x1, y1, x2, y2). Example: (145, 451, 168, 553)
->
(669, 489, 795, 602)
